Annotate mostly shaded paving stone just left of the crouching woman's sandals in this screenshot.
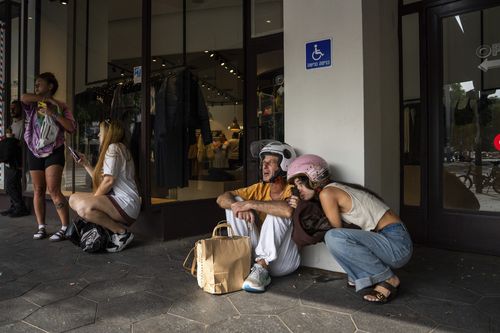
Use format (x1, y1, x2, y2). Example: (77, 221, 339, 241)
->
(300, 280, 367, 313)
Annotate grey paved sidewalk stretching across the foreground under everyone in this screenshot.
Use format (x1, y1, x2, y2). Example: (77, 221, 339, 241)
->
(0, 216, 500, 333)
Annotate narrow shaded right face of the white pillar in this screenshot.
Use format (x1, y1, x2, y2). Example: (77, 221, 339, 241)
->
(363, 0, 400, 211)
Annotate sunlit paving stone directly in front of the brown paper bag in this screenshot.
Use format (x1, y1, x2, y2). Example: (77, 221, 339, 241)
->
(169, 293, 238, 324)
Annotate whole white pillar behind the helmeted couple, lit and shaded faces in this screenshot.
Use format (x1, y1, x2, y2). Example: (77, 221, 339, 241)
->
(284, 0, 399, 270)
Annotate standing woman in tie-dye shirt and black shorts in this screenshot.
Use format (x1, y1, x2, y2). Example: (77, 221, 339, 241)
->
(21, 72, 75, 241)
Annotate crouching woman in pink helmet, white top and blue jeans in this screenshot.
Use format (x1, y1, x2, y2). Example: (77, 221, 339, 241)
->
(287, 155, 413, 303)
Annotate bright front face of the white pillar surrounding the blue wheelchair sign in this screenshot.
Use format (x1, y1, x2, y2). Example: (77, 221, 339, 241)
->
(283, 0, 365, 184)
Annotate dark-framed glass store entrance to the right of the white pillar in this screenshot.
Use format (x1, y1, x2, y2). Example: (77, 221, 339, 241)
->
(402, 0, 500, 255)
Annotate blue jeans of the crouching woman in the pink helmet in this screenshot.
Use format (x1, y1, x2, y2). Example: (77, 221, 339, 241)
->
(325, 223, 413, 291)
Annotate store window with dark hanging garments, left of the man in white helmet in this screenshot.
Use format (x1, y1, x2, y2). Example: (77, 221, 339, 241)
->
(147, 1, 244, 204)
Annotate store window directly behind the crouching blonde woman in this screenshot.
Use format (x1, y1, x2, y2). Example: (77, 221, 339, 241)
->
(73, 0, 142, 192)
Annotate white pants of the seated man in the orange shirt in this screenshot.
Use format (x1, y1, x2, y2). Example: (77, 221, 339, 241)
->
(226, 205, 300, 276)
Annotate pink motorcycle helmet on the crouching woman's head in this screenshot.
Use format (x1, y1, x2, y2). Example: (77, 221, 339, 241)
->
(287, 154, 331, 189)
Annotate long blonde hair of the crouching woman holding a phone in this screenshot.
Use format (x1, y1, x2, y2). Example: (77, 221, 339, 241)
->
(92, 120, 125, 191)
